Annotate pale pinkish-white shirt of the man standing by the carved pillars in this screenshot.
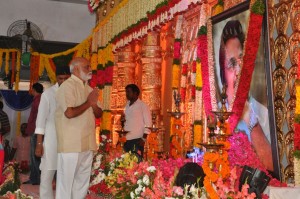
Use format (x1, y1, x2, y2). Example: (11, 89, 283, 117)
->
(124, 99, 152, 140)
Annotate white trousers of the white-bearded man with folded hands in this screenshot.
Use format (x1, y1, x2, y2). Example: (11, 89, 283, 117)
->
(56, 151, 93, 199)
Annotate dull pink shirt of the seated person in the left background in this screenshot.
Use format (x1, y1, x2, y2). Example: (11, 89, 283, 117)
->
(13, 136, 30, 162)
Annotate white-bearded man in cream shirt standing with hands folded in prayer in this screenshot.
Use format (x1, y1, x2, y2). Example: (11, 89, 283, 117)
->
(55, 58, 102, 199)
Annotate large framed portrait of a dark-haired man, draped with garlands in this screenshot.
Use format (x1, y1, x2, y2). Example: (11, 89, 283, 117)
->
(211, 0, 281, 179)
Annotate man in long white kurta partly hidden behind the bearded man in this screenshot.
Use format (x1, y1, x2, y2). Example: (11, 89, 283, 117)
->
(35, 66, 70, 199)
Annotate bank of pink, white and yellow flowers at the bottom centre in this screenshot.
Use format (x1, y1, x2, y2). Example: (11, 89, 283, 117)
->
(90, 153, 206, 199)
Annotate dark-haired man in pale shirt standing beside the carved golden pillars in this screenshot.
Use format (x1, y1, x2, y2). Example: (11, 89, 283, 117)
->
(124, 84, 152, 156)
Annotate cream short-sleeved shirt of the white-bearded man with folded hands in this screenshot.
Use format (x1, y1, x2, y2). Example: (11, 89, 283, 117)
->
(55, 75, 96, 153)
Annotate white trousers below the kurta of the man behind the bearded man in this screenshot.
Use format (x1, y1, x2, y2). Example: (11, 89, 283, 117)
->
(40, 169, 56, 199)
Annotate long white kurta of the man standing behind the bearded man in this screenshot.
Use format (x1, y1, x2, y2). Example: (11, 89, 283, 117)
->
(35, 83, 58, 170)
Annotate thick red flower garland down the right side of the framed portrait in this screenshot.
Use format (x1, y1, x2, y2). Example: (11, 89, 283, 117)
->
(229, 13, 263, 131)
